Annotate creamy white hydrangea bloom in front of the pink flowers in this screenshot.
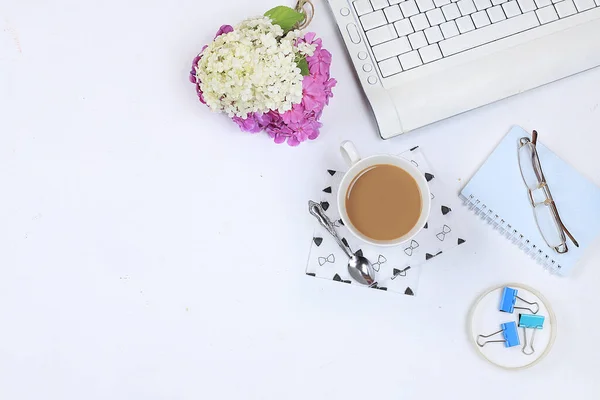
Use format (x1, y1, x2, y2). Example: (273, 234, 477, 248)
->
(196, 17, 304, 118)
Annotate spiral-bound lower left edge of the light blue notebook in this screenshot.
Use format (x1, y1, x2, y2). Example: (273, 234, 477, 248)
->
(460, 194, 562, 273)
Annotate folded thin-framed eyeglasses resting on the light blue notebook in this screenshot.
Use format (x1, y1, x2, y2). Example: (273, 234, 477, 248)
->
(518, 131, 579, 254)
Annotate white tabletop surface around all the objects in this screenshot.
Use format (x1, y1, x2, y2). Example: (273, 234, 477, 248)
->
(0, 0, 600, 400)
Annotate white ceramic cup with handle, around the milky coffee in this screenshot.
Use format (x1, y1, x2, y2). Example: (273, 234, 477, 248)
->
(337, 141, 431, 246)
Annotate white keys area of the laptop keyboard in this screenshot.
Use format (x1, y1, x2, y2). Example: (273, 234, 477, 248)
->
(348, 0, 600, 78)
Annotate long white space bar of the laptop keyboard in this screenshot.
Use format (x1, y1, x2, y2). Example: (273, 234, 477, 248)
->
(439, 11, 540, 57)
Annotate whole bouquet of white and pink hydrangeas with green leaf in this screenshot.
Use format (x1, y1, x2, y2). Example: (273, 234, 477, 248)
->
(190, 0, 337, 146)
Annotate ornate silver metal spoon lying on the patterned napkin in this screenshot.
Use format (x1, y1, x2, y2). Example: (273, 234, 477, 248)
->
(308, 200, 375, 286)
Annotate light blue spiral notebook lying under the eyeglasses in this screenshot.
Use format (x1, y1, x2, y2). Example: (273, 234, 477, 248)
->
(460, 126, 600, 275)
